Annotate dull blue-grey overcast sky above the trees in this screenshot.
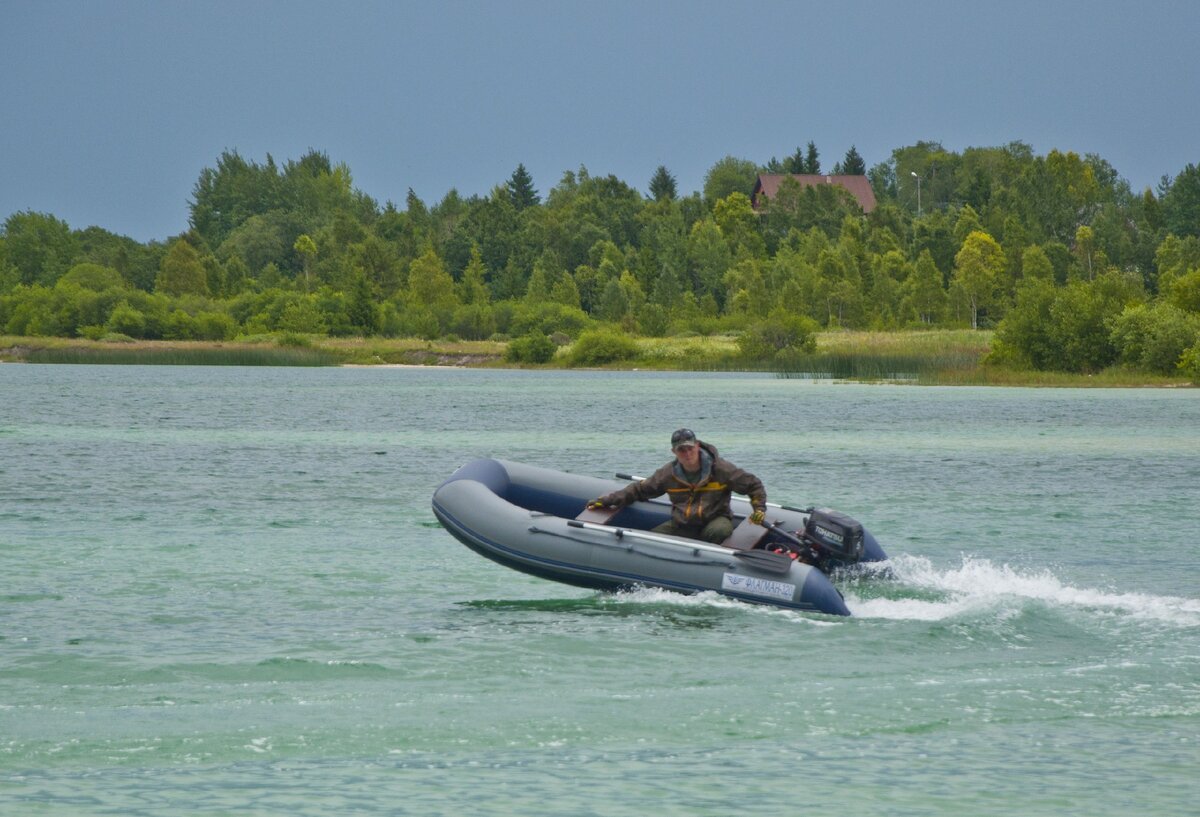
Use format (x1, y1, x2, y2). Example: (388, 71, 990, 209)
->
(0, 0, 1200, 241)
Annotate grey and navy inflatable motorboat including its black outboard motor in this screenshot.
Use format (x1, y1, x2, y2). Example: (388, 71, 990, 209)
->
(433, 458, 887, 615)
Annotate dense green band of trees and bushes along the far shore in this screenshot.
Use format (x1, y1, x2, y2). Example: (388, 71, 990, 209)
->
(0, 142, 1200, 376)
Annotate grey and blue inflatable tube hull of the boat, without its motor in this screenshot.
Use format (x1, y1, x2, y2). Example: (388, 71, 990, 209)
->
(433, 459, 882, 615)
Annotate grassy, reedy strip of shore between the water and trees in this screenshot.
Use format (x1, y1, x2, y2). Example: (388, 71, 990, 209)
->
(0, 330, 1196, 389)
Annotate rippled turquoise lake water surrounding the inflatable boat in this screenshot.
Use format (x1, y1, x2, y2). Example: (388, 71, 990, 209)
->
(0, 365, 1200, 817)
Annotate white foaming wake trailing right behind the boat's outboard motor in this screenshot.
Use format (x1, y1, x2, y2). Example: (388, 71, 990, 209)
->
(846, 555, 1200, 627)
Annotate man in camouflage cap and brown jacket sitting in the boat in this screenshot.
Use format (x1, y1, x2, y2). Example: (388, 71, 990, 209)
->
(588, 428, 767, 545)
